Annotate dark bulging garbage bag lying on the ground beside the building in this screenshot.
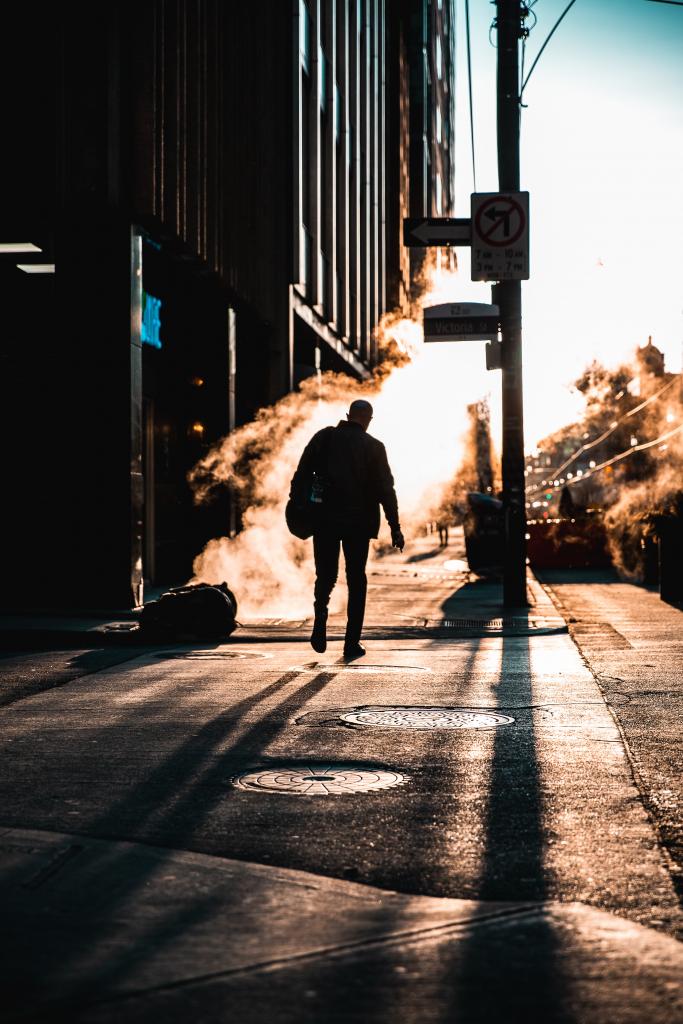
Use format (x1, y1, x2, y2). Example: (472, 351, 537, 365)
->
(140, 583, 238, 641)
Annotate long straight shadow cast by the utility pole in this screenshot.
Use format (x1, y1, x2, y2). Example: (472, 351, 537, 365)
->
(444, 618, 574, 1024)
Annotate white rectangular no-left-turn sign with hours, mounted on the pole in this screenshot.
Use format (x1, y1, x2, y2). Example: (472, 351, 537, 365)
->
(471, 193, 528, 281)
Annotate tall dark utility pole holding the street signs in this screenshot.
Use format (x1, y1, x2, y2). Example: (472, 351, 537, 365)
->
(495, 0, 528, 607)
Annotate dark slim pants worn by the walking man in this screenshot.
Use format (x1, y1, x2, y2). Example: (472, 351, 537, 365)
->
(313, 528, 370, 645)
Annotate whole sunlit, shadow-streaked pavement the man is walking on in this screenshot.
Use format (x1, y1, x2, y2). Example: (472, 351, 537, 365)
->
(0, 544, 683, 1024)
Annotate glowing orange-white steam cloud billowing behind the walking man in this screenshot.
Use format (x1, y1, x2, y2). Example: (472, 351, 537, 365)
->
(189, 271, 488, 620)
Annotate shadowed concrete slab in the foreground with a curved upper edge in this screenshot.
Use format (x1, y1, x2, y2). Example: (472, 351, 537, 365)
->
(0, 829, 683, 1024)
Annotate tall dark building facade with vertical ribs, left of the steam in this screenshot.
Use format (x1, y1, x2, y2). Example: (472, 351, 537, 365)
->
(0, 0, 454, 608)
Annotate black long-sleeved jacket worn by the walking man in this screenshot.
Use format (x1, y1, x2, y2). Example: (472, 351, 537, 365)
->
(290, 420, 399, 537)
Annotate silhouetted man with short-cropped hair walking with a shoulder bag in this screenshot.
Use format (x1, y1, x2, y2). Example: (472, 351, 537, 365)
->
(290, 398, 403, 662)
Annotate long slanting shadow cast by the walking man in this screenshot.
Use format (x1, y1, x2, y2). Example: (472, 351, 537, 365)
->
(4, 672, 342, 1019)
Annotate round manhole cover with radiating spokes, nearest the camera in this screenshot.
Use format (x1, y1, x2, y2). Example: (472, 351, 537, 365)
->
(232, 764, 407, 797)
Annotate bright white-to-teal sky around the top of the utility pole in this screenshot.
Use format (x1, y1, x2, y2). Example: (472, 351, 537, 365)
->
(454, 0, 683, 450)
